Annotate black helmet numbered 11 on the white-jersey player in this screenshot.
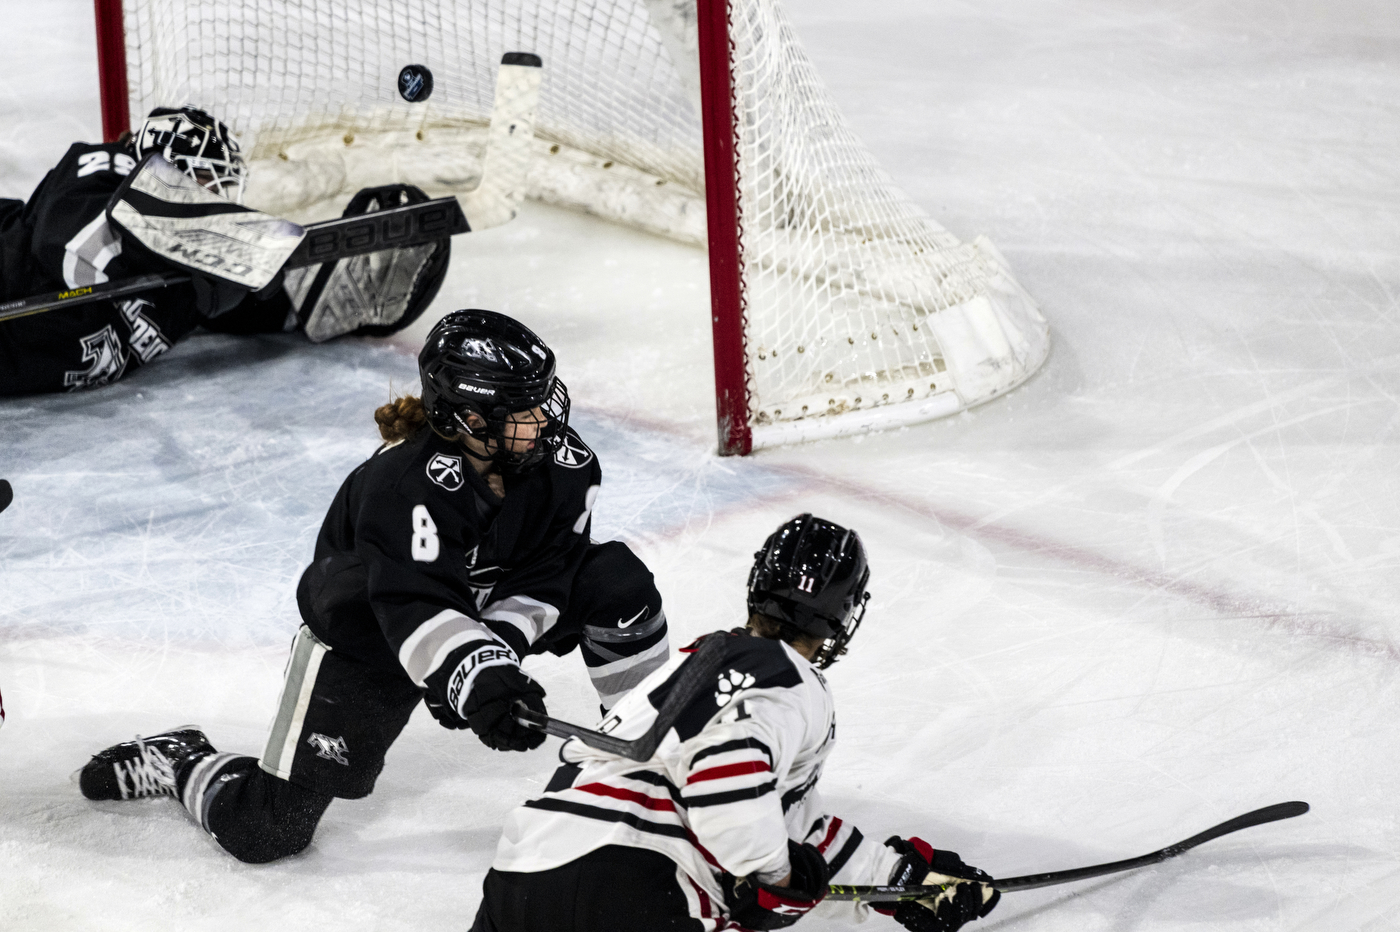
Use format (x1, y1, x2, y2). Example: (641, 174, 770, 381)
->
(749, 514, 871, 668)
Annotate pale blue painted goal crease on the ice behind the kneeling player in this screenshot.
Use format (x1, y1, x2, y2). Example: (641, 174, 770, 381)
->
(0, 334, 812, 644)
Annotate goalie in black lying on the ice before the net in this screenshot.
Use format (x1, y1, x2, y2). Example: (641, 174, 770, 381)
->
(0, 106, 451, 396)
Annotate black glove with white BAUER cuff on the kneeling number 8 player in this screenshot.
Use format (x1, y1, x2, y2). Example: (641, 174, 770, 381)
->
(423, 640, 546, 750)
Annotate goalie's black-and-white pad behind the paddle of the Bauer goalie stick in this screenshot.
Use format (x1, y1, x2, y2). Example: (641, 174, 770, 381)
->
(286, 185, 452, 343)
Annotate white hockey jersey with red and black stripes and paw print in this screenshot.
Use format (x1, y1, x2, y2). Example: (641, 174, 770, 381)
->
(493, 634, 899, 929)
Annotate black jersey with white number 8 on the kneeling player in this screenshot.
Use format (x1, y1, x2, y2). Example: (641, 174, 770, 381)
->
(297, 428, 602, 687)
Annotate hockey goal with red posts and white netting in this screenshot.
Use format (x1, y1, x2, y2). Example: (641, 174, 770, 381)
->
(95, 0, 1049, 453)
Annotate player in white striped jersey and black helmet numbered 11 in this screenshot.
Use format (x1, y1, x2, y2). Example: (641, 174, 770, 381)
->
(472, 515, 1000, 932)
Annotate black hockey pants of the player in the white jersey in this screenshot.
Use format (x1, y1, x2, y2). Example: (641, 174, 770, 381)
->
(472, 845, 704, 932)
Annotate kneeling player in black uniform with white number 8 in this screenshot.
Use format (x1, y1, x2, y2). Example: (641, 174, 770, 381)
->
(78, 311, 668, 862)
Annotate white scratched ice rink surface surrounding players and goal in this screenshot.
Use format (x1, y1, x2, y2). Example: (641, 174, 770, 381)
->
(0, 0, 1400, 932)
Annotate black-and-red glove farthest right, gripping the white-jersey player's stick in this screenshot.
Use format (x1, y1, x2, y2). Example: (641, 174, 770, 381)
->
(874, 835, 1001, 932)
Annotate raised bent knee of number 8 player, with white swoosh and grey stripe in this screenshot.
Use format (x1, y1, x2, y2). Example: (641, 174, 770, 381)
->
(560, 540, 671, 708)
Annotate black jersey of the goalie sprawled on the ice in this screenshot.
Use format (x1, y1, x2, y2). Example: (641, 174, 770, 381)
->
(0, 143, 200, 395)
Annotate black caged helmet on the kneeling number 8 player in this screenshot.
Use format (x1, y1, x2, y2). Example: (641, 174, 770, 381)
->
(419, 309, 568, 472)
